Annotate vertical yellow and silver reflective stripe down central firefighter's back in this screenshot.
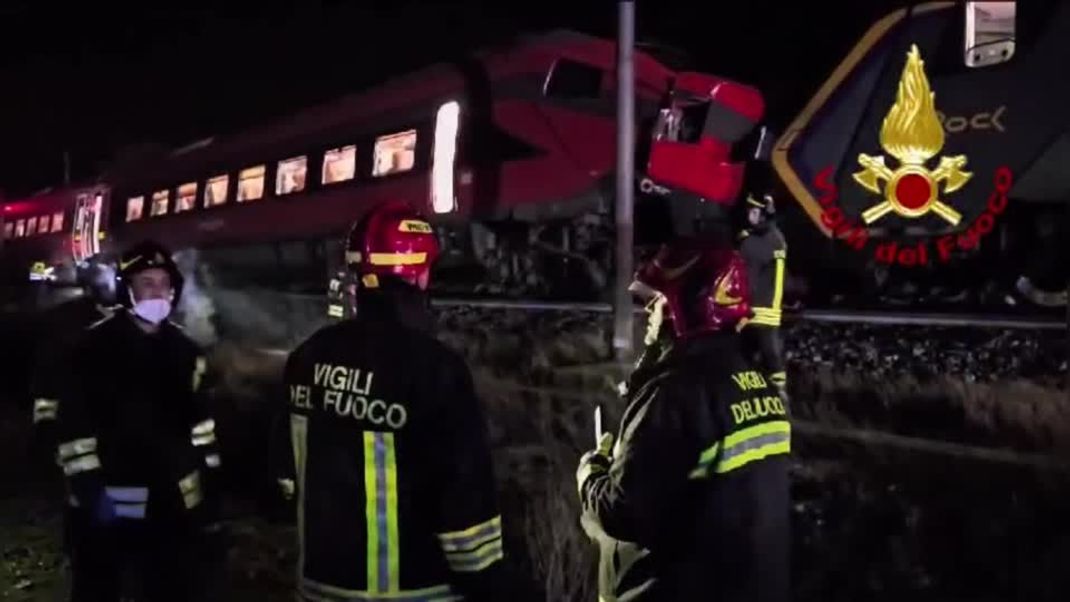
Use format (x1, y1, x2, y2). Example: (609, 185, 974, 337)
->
(364, 431, 400, 593)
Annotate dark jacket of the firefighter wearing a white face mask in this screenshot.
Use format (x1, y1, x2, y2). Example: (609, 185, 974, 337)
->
(57, 310, 220, 524)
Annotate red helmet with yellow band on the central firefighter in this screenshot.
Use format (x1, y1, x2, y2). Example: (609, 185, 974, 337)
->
(346, 201, 439, 289)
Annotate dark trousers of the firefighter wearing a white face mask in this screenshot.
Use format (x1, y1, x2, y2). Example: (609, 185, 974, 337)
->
(68, 513, 209, 602)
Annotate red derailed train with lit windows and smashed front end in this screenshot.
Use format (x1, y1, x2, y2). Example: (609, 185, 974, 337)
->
(0, 32, 764, 314)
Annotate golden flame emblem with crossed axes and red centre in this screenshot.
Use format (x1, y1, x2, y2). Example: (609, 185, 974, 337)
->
(854, 45, 973, 226)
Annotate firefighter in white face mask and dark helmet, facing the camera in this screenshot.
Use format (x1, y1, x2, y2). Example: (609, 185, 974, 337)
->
(58, 242, 221, 602)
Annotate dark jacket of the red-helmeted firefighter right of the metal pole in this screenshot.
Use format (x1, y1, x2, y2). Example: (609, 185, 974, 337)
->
(580, 335, 791, 602)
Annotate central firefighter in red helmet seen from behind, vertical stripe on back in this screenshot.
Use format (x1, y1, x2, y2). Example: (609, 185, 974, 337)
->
(280, 203, 503, 601)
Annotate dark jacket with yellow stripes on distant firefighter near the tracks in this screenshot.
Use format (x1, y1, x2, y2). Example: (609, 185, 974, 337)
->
(739, 221, 788, 327)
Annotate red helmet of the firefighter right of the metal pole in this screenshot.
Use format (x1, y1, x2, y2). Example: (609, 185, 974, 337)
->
(636, 242, 751, 339)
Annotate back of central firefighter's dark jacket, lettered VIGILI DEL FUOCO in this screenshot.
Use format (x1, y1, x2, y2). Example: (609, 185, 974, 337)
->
(286, 311, 478, 600)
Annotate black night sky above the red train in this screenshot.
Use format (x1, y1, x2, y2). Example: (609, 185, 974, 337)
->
(0, 0, 905, 198)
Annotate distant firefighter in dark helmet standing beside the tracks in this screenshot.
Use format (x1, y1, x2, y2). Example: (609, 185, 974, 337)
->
(738, 192, 788, 401)
